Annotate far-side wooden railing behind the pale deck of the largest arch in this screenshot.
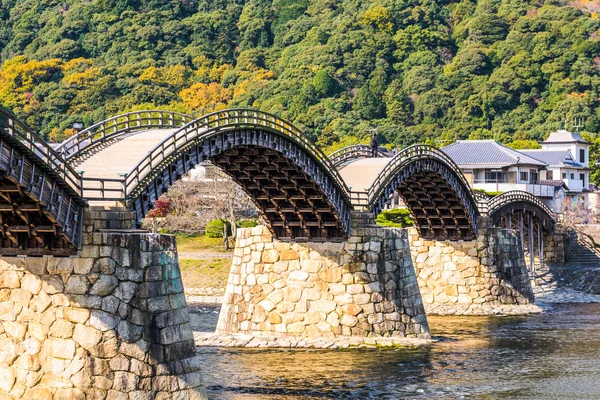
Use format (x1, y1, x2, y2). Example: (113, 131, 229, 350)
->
(56, 110, 192, 160)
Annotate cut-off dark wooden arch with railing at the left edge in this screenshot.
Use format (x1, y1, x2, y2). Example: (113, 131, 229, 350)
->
(0, 108, 86, 256)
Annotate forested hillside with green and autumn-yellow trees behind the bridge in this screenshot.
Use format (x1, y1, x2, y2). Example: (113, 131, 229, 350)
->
(0, 0, 600, 150)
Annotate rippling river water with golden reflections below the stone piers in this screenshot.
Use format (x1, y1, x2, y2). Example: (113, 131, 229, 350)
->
(199, 304, 600, 400)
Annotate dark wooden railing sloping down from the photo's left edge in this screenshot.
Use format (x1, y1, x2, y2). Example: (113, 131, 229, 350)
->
(0, 107, 82, 196)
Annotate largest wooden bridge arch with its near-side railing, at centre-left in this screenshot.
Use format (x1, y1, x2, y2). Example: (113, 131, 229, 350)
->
(79, 109, 352, 240)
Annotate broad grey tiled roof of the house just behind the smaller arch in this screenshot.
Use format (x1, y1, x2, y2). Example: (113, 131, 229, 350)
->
(441, 140, 546, 167)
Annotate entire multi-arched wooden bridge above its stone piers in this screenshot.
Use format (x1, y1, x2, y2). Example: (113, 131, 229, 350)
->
(0, 109, 552, 253)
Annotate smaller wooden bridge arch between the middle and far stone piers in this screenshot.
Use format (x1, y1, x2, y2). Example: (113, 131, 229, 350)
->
(368, 145, 479, 240)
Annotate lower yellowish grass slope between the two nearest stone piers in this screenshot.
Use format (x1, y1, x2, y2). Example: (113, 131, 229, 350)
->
(179, 258, 231, 288)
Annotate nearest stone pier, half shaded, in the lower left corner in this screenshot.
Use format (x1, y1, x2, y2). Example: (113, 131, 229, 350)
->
(0, 211, 205, 400)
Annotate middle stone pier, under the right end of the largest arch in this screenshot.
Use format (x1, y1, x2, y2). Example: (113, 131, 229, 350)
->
(217, 222, 430, 338)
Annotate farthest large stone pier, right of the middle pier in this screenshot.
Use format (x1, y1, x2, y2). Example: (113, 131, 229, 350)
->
(409, 228, 533, 314)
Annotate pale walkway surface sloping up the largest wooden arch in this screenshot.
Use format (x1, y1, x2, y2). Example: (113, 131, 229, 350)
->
(75, 129, 175, 179)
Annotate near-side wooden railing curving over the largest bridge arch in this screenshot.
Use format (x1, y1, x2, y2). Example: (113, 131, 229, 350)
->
(83, 109, 350, 201)
